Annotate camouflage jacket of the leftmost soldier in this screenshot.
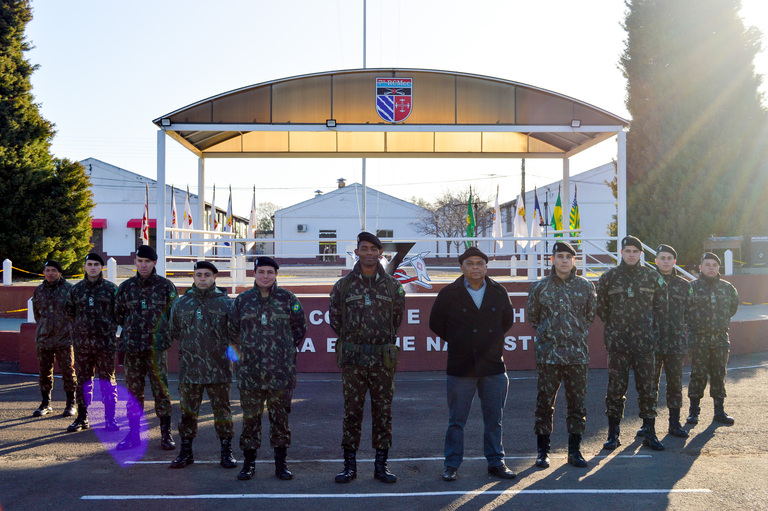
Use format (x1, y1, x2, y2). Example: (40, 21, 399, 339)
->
(32, 277, 72, 349)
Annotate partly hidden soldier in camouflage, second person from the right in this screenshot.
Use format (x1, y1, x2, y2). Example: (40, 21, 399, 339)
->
(637, 244, 692, 438)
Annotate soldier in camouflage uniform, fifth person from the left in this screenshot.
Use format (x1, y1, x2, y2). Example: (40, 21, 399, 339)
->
(234, 256, 307, 481)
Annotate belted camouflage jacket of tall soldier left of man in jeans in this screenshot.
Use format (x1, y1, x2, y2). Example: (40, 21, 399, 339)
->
(329, 262, 405, 366)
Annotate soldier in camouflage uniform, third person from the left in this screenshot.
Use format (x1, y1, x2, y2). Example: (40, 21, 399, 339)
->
(115, 245, 177, 451)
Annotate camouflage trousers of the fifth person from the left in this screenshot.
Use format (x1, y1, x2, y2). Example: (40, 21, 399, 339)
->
(240, 389, 293, 451)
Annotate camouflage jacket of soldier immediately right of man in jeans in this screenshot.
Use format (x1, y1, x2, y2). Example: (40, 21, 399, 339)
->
(527, 268, 597, 365)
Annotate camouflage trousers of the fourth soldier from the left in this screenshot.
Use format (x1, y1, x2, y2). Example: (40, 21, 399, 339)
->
(179, 382, 235, 438)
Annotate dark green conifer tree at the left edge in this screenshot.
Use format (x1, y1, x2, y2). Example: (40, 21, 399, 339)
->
(0, 0, 93, 272)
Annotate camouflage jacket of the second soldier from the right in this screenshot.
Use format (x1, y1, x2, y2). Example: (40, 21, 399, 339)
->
(654, 269, 692, 355)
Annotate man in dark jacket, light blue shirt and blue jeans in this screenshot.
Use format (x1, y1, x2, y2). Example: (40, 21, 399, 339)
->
(429, 247, 515, 481)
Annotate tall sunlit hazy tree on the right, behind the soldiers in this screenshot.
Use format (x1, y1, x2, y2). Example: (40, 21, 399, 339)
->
(620, 0, 768, 263)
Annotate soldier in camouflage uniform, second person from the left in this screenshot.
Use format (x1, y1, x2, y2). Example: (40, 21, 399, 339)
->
(64, 253, 120, 432)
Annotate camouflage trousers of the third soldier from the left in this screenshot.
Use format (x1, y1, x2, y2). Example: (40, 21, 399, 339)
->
(123, 350, 171, 418)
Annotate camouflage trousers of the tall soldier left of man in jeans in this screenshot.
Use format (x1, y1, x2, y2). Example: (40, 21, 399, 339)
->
(341, 365, 395, 451)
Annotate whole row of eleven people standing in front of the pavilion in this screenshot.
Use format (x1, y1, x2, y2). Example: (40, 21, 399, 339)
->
(33, 232, 739, 483)
